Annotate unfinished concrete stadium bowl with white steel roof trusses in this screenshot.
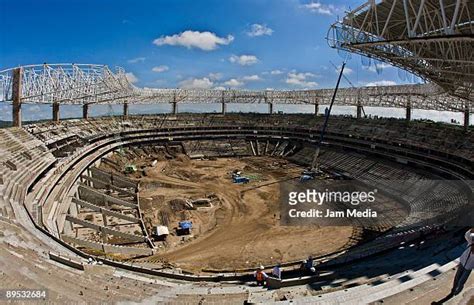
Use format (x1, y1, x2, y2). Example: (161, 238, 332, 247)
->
(0, 0, 474, 304)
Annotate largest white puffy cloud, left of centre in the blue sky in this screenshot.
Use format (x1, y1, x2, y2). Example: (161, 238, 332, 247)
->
(153, 30, 234, 51)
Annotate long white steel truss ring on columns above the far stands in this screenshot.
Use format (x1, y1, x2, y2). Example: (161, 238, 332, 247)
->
(0, 63, 474, 113)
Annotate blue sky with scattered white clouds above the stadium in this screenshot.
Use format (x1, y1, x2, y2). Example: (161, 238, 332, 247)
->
(0, 0, 466, 123)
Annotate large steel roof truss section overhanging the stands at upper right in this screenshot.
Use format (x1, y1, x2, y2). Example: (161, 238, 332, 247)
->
(327, 0, 474, 103)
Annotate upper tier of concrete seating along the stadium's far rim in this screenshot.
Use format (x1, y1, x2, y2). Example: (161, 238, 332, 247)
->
(27, 114, 474, 165)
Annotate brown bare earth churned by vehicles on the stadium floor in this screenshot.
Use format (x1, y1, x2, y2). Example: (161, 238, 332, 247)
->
(119, 155, 352, 272)
